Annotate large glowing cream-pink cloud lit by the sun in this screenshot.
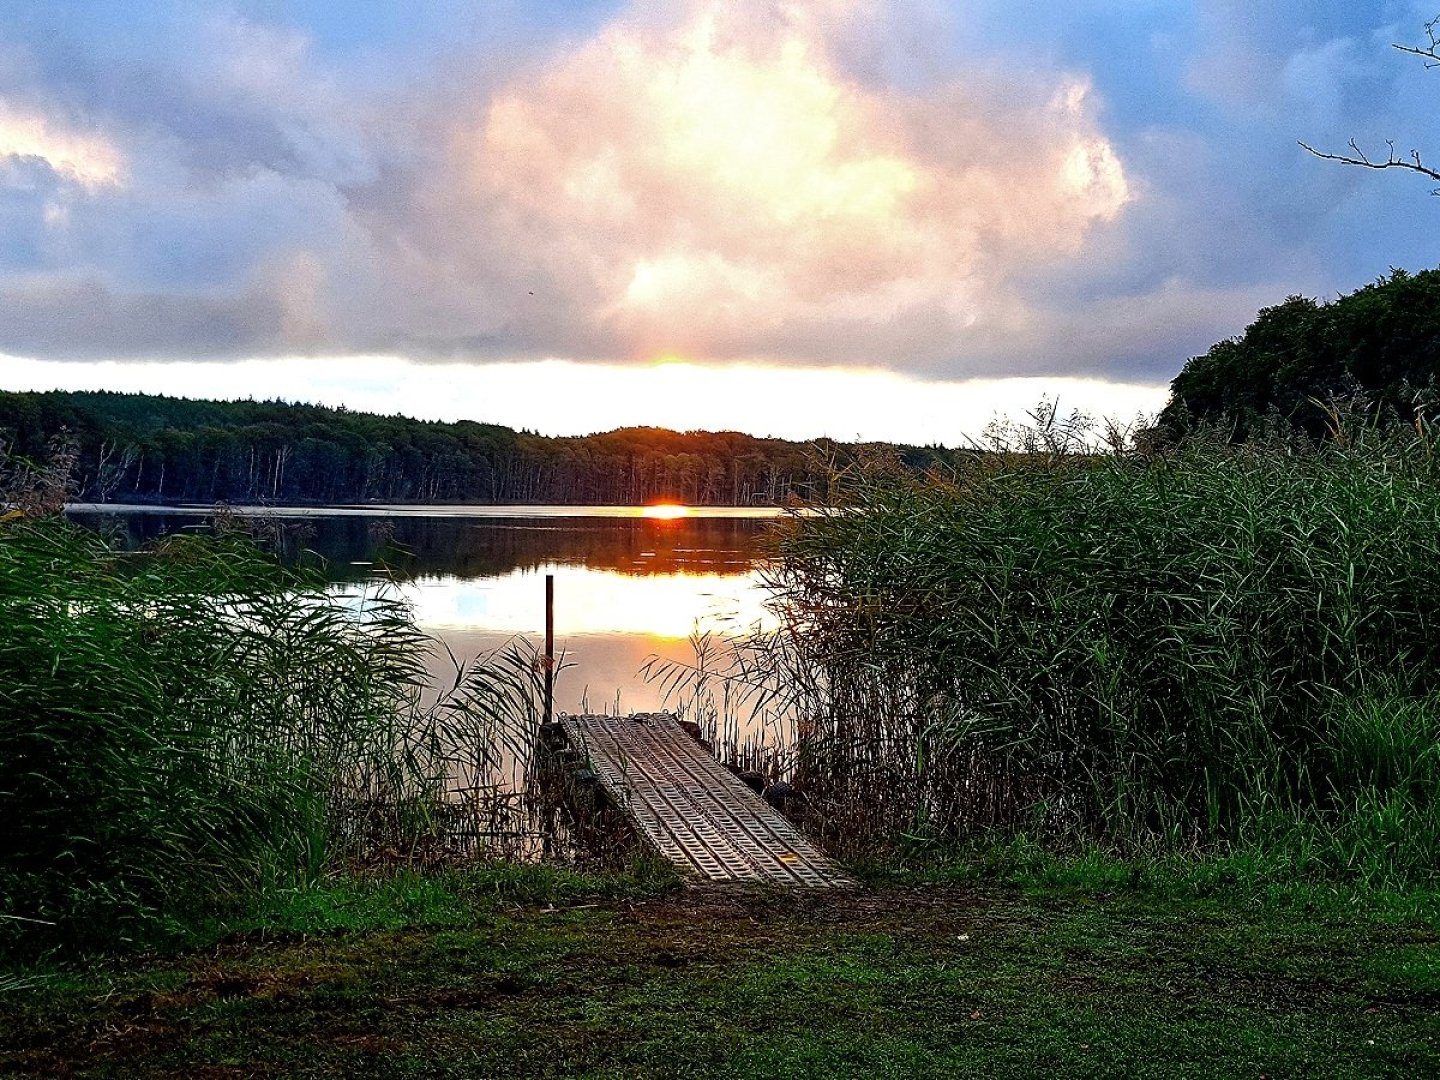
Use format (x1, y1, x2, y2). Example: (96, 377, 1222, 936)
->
(397, 3, 1129, 366)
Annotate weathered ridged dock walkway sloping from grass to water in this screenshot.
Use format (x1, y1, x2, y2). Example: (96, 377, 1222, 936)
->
(560, 714, 852, 888)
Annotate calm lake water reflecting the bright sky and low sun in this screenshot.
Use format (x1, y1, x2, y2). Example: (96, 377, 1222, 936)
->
(72, 507, 775, 711)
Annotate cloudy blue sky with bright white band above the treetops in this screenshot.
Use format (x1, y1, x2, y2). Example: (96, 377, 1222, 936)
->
(0, 0, 1440, 445)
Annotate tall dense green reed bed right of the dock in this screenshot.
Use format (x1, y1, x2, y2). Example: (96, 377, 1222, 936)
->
(671, 429, 1440, 881)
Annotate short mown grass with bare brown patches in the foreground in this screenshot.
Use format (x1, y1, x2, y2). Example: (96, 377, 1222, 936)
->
(0, 870, 1440, 1080)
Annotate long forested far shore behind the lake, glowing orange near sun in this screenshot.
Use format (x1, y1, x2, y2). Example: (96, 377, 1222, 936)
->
(0, 392, 963, 505)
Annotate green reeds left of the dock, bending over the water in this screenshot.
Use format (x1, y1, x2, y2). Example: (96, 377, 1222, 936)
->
(0, 518, 539, 949)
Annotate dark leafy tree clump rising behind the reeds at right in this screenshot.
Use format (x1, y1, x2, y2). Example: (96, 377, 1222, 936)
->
(1156, 271, 1440, 441)
